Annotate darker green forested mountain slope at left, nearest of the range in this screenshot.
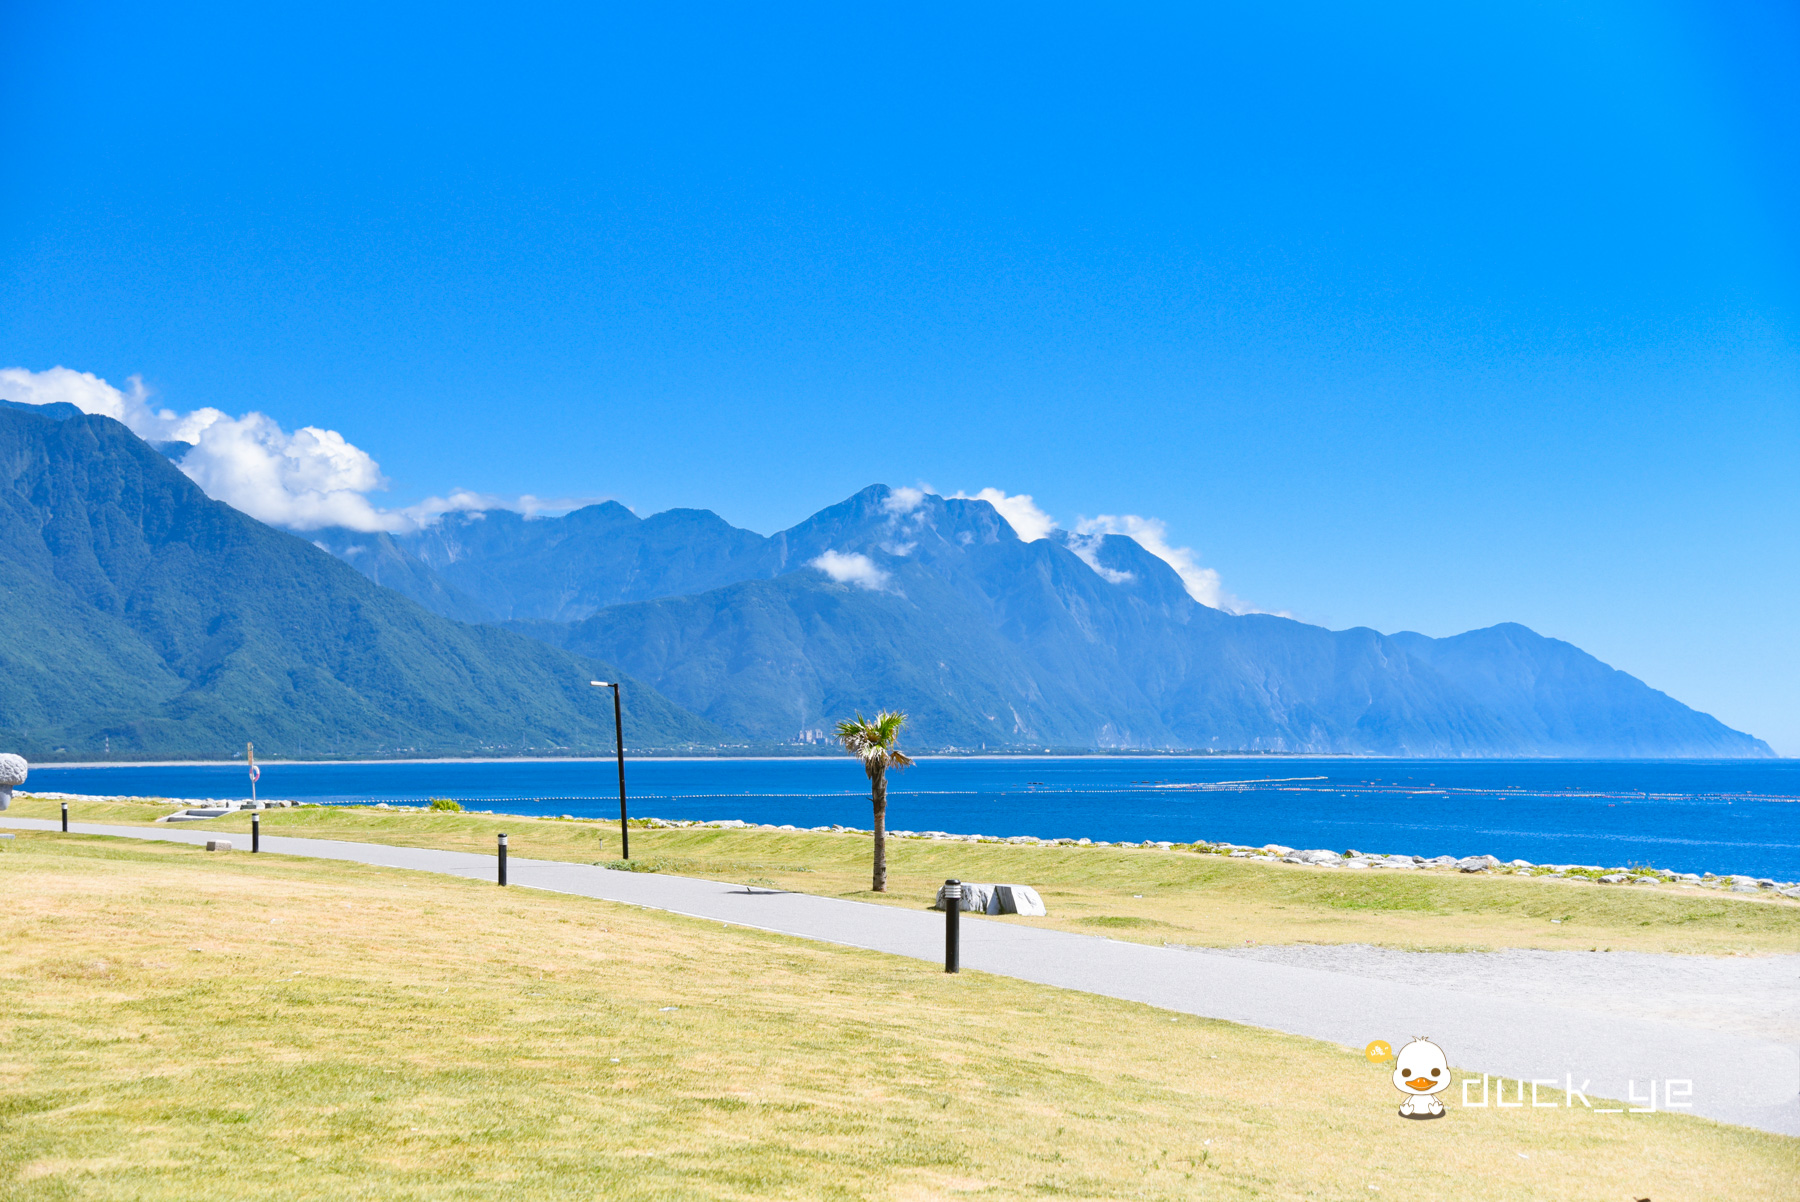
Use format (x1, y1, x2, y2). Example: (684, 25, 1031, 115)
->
(0, 405, 720, 758)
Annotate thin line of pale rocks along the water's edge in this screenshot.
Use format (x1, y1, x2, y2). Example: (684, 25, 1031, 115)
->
(20, 794, 1800, 902)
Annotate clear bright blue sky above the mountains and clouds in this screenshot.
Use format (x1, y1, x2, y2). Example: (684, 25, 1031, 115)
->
(0, 0, 1800, 754)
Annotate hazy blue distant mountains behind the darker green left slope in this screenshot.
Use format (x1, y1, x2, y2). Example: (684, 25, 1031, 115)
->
(320, 486, 1771, 756)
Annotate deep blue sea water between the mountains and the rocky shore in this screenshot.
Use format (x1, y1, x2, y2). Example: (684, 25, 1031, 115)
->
(29, 756, 1800, 880)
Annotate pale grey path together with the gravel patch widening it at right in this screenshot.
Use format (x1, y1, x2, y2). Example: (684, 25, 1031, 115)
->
(0, 819, 1800, 1135)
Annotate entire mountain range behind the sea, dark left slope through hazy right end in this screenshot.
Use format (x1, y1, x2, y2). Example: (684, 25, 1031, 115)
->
(0, 403, 1771, 759)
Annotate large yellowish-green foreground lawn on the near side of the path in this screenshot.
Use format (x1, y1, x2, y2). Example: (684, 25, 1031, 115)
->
(0, 831, 1800, 1202)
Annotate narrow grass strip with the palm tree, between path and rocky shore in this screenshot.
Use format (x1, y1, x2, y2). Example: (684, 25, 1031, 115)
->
(11, 797, 1800, 954)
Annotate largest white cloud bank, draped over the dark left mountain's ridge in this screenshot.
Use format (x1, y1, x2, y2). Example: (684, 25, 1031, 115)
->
(0, 367, 500, 533)
